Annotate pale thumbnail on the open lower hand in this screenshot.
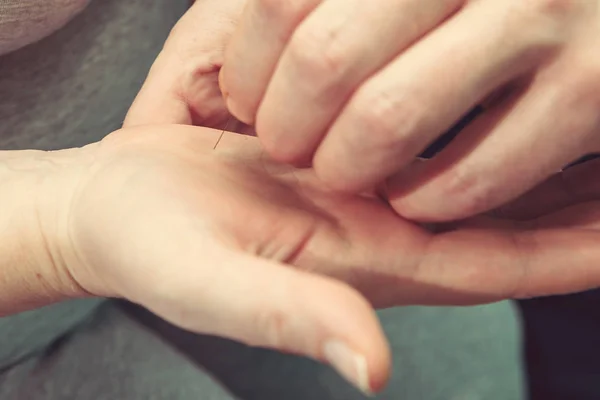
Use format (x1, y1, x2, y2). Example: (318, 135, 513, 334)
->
(323, 340, 373, 396)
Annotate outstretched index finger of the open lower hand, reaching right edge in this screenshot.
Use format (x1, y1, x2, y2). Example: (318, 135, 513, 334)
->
(404, 229, 600, 305)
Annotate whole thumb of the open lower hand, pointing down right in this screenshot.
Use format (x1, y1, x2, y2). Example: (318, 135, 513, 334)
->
(145, 250, 390, 394)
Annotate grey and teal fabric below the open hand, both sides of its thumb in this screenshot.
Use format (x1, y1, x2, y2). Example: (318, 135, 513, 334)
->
(0, 303, 522, 400)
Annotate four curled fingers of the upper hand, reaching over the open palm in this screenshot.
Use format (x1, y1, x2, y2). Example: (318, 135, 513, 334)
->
(221, 0, 600, 221)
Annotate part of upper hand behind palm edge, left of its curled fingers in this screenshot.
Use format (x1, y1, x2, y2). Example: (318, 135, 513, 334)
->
(124, 0, 252, 133)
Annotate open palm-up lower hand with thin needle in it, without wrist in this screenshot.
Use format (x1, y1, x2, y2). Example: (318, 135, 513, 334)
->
(54, 125, 600, 390)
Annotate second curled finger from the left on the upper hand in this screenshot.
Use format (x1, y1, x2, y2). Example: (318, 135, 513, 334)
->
(257, 0, 465, 162)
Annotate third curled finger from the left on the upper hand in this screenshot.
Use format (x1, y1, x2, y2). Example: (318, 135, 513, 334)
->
(314, 0, 563, 191)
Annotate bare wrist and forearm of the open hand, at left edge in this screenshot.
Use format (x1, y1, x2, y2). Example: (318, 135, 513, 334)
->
(0, 150, 90, 316)
